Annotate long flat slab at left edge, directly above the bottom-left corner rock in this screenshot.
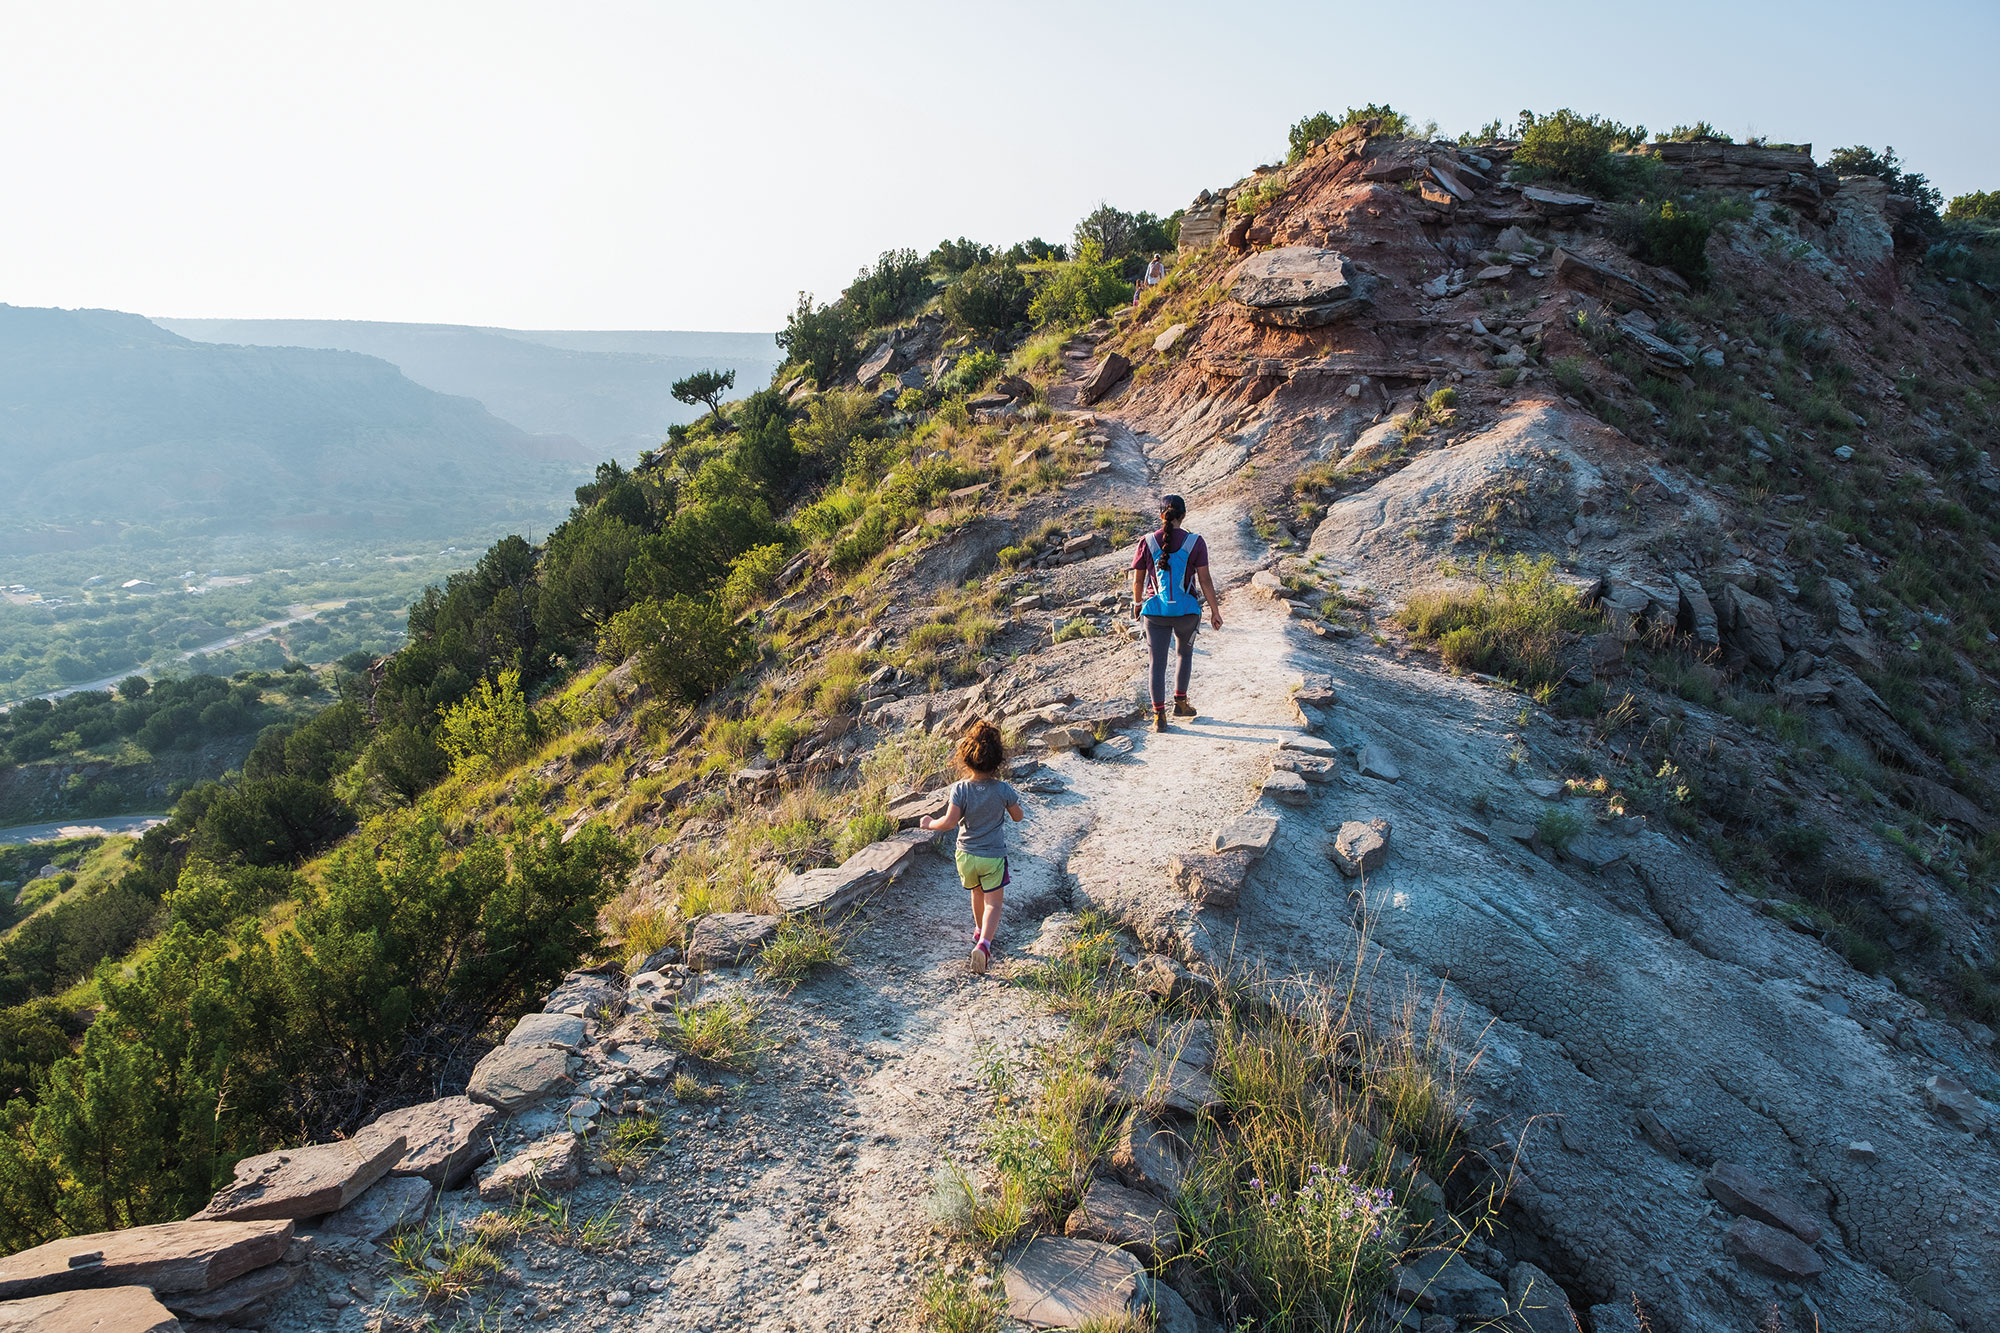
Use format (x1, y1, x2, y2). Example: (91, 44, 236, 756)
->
(0, 1221, 292, 1301)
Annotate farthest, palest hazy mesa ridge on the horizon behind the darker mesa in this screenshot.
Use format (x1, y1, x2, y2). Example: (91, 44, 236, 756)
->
(154, 318, 780, 458)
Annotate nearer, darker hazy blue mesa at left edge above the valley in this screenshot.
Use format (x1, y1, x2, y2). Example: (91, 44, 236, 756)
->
(0, 306, 596, 552)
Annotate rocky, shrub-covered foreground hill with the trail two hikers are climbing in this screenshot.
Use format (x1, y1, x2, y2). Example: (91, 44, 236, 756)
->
(0, 108, 2000, 1333)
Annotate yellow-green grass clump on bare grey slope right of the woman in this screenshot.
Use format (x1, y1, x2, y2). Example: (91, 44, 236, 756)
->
(1396, 554, 1600, 691)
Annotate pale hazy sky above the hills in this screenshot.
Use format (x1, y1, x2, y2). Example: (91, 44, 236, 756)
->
(0, 0, 2000, 328)
